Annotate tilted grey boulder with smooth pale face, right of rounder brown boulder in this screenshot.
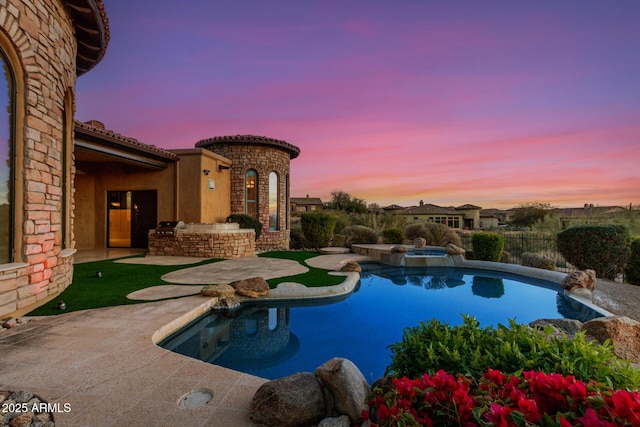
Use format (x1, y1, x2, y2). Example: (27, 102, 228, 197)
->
(316, 357, 371, 424)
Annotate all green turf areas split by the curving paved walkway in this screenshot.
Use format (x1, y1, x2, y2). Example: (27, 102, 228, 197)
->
(29, 251, 344, 316)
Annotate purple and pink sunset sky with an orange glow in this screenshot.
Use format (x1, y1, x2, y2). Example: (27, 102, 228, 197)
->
(76, 0, 640, 208)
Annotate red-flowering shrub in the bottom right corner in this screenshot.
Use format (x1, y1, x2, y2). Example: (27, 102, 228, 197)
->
(362, 369, 640, 427)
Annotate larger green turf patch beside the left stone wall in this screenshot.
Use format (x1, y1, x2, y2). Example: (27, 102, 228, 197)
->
(29, 259, 220, 316)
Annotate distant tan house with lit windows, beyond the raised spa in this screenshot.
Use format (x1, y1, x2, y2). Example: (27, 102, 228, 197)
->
(398, 201, 482, 229)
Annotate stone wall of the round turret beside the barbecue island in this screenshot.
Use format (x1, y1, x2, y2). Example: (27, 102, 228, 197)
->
(201, 142, 291, 250)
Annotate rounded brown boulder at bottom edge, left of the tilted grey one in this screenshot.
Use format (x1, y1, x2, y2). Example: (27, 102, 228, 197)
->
(249, 372, 327, 427)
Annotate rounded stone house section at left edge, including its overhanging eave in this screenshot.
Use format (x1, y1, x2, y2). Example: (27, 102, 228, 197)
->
(0, 0, 109, 318)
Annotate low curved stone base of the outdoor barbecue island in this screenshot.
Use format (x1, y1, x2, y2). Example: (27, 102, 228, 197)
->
(149, 230, 256, 258)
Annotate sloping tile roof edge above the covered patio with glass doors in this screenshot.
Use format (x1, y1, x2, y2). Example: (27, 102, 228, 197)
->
(74, 120, 178, 160)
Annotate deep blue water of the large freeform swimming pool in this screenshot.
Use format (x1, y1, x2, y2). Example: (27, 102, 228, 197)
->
(160, 264, 600, 382)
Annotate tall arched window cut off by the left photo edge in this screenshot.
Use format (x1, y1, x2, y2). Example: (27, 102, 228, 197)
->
(0, 49, 15, 264)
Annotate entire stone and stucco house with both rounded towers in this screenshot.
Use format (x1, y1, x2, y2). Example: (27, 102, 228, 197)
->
(0, 0, 300, 319)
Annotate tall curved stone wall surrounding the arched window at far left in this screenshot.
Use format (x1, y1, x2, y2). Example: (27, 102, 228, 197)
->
(0, 0, 77, 318)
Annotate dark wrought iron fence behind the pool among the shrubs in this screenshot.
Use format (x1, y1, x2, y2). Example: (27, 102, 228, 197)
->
(458, 231, 576, 272)
